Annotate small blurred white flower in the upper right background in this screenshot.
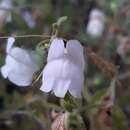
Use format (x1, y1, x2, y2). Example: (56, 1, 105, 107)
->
(86, 9, 105, 37)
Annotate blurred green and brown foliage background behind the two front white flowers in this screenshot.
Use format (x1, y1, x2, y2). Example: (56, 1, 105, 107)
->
(0, 0, 130, 130)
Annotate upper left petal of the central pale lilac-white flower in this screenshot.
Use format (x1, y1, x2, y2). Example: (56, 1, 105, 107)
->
(47, 38, 64, 61)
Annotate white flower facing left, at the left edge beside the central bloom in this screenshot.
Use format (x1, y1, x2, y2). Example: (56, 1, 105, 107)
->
(1, 37, 38, 86)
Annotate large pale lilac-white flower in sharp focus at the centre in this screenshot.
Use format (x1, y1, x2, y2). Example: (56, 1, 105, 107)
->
(40, 38, 85, 97)
